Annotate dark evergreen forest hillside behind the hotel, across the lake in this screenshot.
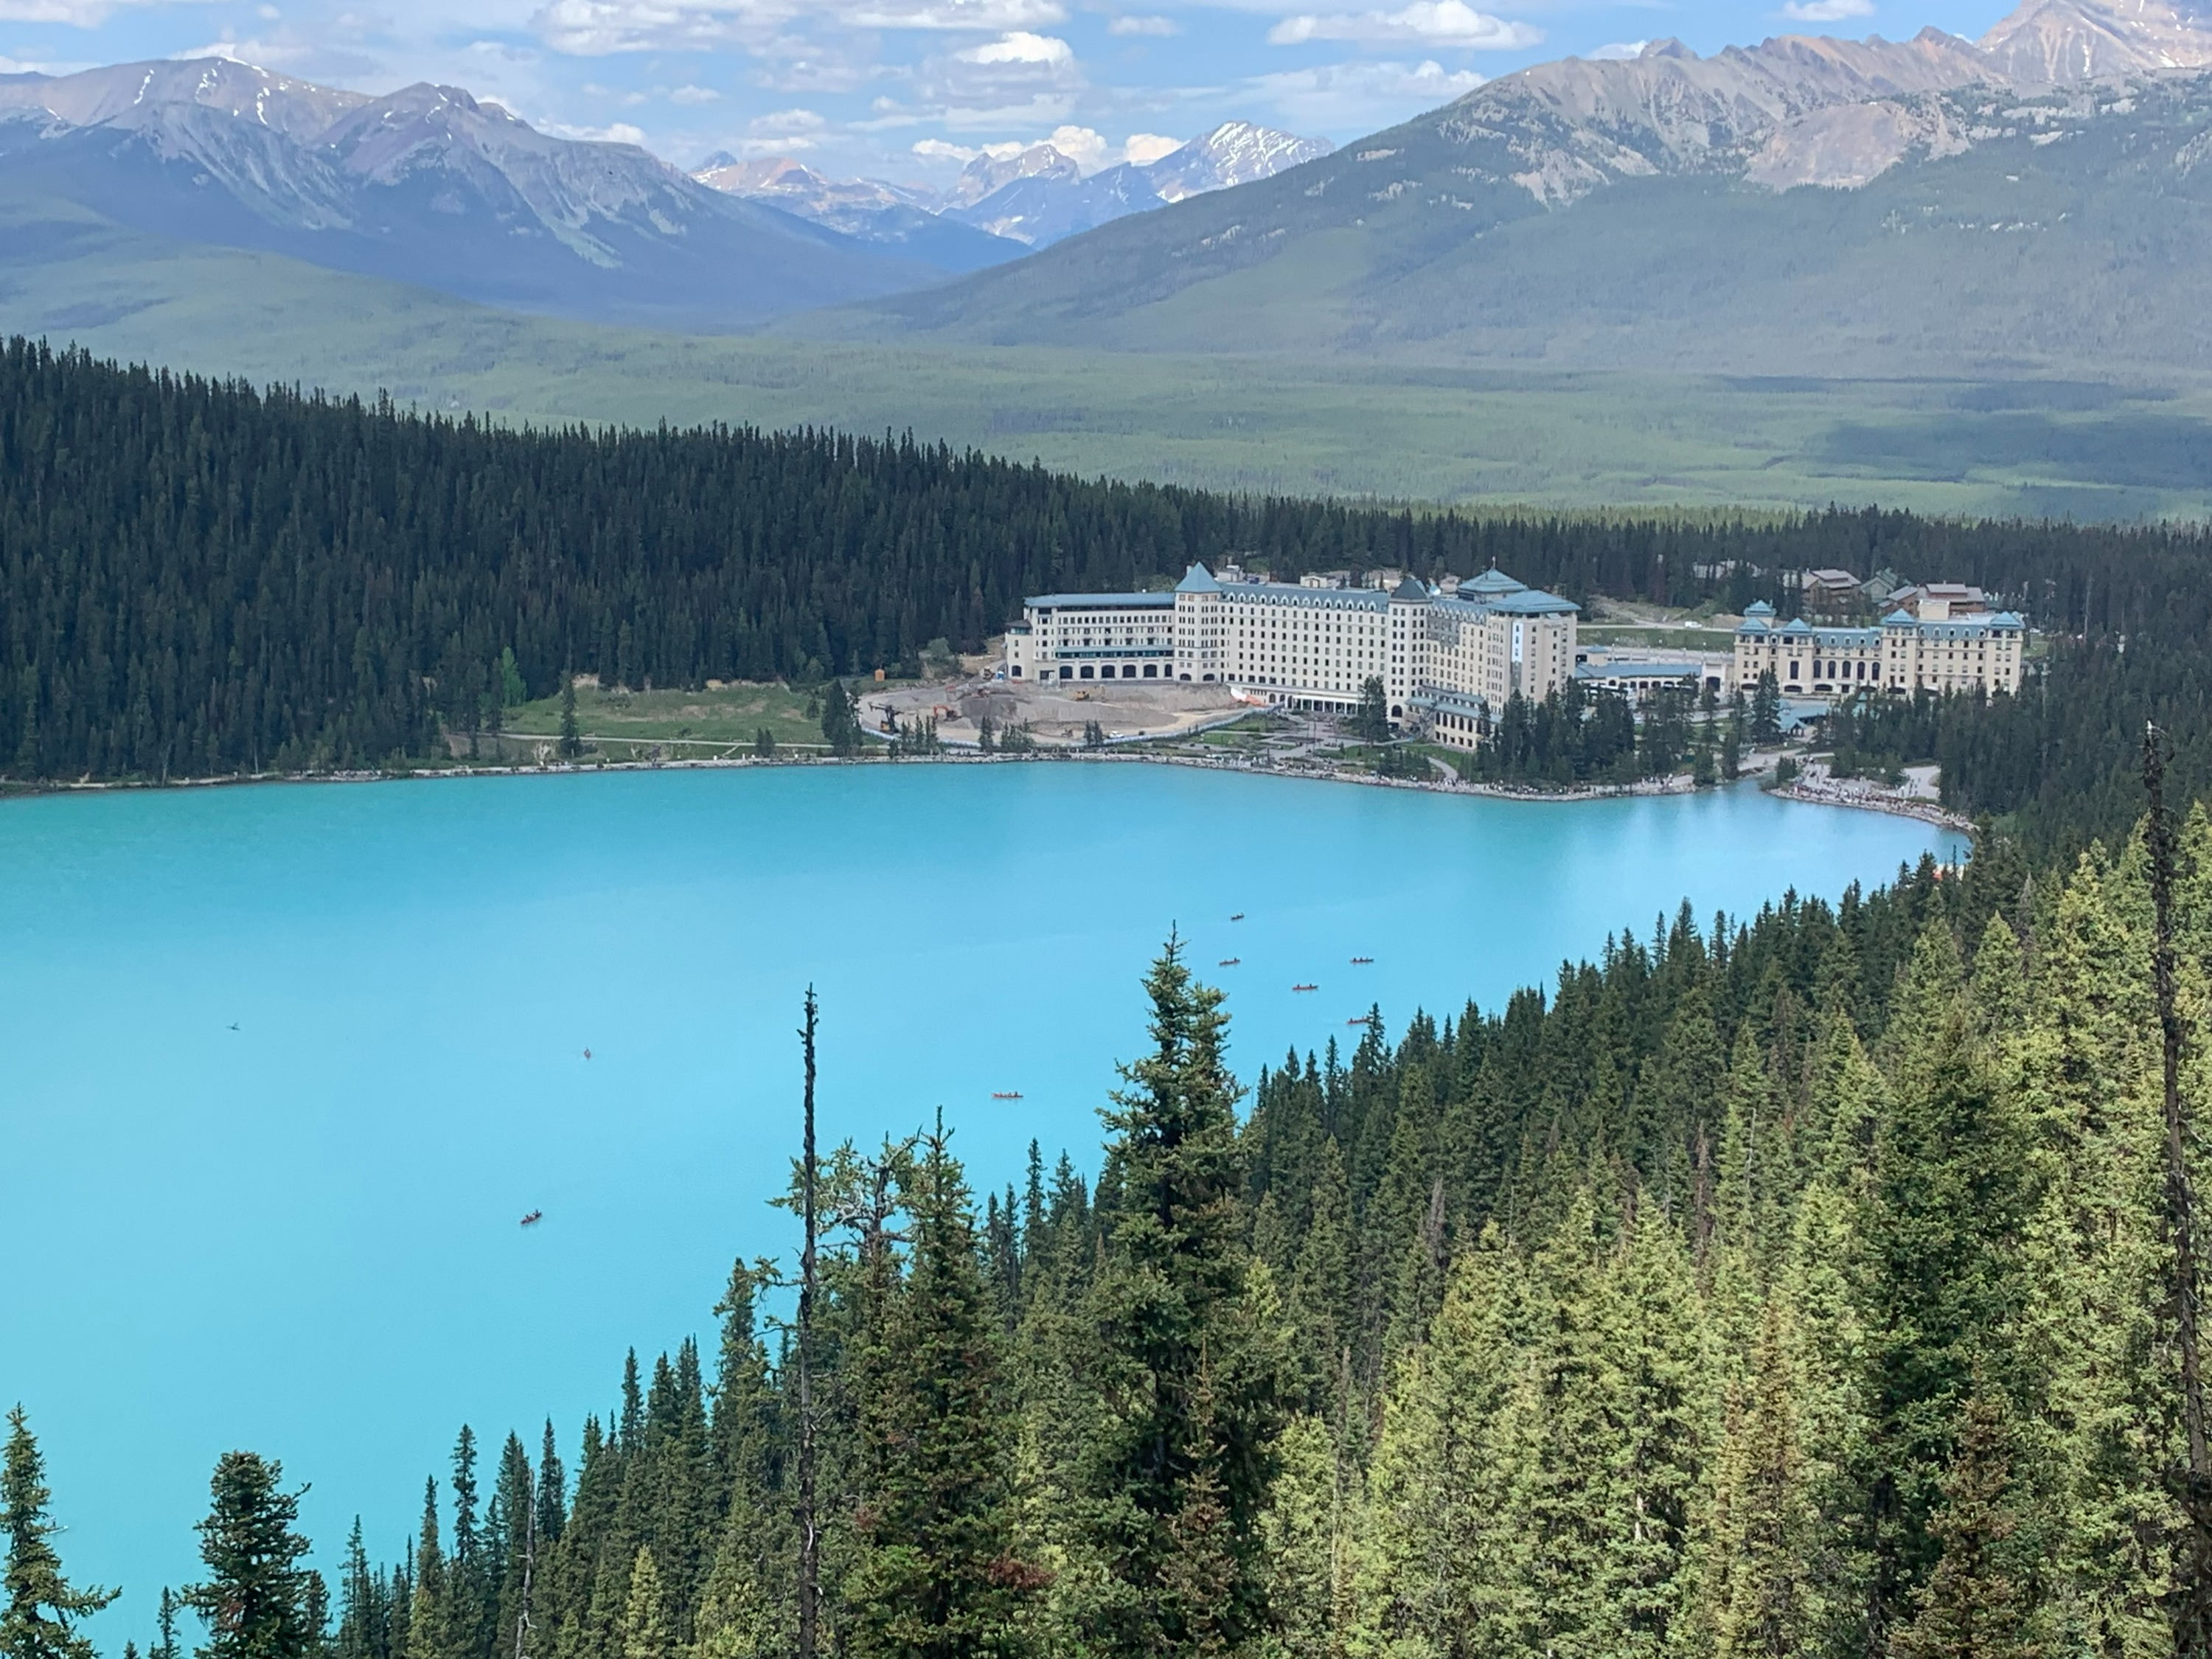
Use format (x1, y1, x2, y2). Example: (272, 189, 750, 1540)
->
(0, 341, 2212, 845)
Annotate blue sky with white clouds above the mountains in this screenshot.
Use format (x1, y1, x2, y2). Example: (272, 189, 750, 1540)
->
(0, 0, 2011, 184)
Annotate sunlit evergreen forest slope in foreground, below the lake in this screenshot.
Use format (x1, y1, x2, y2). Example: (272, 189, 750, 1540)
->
(11, 814, 2212, 1659)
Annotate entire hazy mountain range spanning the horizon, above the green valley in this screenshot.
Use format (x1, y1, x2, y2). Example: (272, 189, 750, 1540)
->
(0, 0, 2212, 383)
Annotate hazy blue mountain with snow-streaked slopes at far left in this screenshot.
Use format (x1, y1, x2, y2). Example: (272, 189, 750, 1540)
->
(0, 60, 947, 332)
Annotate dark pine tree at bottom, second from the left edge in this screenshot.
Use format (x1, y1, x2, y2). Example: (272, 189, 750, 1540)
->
(184, 1451, 323, 1659)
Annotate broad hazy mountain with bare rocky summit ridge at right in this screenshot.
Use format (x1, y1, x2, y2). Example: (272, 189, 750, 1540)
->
(810, 0, 2212, 374)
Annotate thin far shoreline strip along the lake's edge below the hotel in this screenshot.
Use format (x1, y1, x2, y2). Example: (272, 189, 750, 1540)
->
(0, 748, 1973, 834)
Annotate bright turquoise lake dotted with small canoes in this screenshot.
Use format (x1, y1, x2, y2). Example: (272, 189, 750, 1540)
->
(0, 763, 1958, 1652)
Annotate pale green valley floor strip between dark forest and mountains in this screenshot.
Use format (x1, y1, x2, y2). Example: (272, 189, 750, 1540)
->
(0, 173, 2212, 518)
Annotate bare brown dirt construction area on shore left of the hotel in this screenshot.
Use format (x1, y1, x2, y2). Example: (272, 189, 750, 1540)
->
(860, 677, 1254, 748)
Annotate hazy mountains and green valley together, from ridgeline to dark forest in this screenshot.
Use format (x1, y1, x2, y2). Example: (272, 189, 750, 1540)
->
(0, 0, 2212, 518)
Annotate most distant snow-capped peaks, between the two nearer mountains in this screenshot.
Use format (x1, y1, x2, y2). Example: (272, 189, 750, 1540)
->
(692, 122, 1334, 252)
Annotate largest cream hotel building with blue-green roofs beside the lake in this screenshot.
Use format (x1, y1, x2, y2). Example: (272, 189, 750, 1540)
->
(1006, 564, 1577, 748)
